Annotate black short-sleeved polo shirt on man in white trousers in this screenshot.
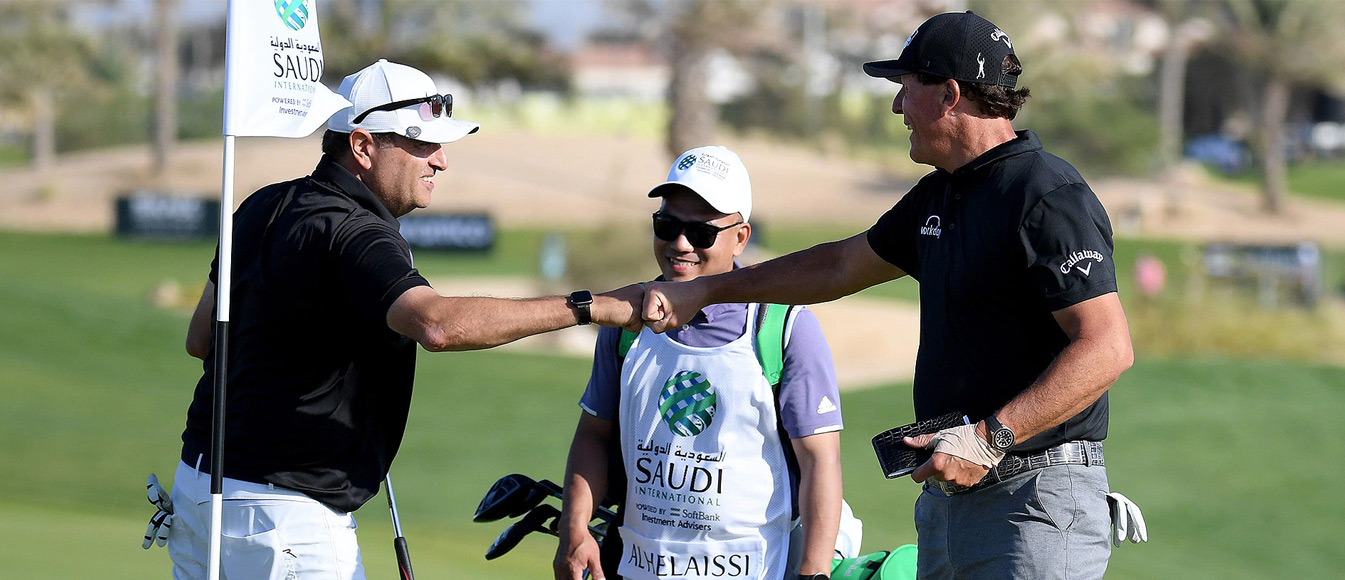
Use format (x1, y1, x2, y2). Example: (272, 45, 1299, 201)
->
(182, 157, 428, 511)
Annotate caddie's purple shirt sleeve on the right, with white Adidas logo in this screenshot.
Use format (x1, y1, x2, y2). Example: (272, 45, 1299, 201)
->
(780, 308, 843, 439)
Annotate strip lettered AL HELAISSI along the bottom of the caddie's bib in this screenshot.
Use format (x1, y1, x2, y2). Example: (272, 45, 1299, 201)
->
(619, 526, 765, 580)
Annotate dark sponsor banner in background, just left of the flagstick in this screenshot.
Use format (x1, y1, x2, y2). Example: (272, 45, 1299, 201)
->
(116, 191, 219, 240)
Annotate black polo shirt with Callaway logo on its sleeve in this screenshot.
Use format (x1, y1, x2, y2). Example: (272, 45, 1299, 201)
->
(868, 131, 1116, 451)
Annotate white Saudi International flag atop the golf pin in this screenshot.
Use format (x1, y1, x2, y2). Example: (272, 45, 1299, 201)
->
(225, 0, 350, 137)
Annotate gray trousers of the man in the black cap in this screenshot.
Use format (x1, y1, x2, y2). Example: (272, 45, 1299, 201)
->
(915, 466, 1111, 580)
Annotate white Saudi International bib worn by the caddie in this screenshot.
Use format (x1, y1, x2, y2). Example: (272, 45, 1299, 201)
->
(619, 304, 792, 580)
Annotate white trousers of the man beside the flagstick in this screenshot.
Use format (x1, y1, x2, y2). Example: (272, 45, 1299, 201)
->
(168, 462, 364, 580)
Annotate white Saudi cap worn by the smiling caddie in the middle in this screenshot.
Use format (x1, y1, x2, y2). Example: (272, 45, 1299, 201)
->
(650, 145, 752, 222)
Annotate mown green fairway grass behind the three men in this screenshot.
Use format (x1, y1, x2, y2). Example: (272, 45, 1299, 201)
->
(0, 228, 1345, 580)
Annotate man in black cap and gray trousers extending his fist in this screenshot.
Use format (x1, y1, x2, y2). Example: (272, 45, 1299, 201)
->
(644, 12, 1132, 580)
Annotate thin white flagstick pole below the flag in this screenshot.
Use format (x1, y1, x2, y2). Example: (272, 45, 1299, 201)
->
(208, 135, 234, 580)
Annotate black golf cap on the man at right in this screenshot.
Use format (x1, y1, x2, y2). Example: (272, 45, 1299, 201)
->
(863, 11, 1018, 89)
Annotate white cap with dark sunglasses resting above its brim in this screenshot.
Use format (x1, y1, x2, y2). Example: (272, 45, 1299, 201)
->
(327, 59, 482, 143)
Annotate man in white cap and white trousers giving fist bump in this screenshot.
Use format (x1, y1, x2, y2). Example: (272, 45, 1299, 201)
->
(156, 61, 642, 579)
